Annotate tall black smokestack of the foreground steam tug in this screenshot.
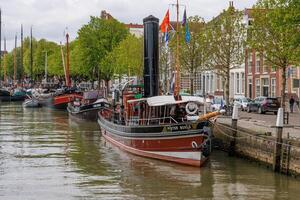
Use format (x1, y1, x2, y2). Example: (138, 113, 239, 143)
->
(143, 15, 159, 97)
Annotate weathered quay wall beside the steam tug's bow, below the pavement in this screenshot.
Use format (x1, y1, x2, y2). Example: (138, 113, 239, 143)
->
(213, 122, 300, 177)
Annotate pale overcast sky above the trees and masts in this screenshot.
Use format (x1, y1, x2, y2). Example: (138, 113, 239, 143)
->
(0, 0, 256, 50)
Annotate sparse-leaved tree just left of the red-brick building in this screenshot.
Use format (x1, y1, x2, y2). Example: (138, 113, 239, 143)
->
(207, 6, 246, 105)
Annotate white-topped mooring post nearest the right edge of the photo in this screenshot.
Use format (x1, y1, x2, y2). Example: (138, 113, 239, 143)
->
(273, 108, 284, 172)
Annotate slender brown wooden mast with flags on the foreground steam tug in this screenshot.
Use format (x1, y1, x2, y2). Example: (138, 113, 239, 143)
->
(174, 0, 180, 97)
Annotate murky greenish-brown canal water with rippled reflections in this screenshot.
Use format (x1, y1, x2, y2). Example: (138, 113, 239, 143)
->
(0, 103, 300, 200)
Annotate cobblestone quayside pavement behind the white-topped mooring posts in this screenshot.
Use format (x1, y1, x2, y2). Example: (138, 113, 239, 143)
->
(217, 106, 300, 139)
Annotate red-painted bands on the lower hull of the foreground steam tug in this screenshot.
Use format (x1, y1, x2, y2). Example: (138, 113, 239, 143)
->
(101, 129, 207, 167)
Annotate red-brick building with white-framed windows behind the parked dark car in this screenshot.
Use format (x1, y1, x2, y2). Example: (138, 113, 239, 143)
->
(244, 9, 300, 98)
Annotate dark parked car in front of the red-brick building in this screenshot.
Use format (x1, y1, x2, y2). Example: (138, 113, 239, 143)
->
(247, 97, 280, 114)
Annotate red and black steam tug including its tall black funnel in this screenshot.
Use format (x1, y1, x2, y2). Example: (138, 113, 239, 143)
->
(98, 16, 221, 167)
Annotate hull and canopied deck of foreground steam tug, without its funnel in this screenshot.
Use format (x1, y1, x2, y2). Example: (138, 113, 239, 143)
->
(98, 96, 220, 167)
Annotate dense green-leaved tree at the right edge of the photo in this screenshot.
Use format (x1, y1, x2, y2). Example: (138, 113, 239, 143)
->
(248, 0, 300, 108)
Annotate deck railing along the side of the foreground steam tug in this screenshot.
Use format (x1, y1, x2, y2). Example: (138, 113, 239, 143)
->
(126, 116, 178, 125)
